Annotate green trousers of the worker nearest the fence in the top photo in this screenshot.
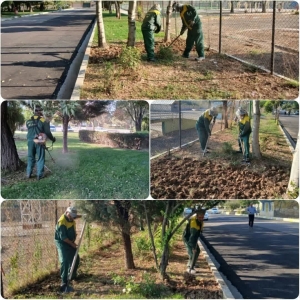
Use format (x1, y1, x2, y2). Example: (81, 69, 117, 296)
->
(183, 25, 205, 57)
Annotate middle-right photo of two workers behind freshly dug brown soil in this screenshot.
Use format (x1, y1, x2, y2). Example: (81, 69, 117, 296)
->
(150, 100, 299, 200)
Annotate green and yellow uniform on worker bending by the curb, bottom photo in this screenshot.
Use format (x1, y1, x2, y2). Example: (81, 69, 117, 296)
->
(183, 216, 204, 269)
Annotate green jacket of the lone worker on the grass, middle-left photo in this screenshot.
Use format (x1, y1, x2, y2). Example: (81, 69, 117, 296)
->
(26, 115, 54, 141)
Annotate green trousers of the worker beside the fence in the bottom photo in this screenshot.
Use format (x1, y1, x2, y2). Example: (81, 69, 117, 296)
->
(55, 241, 80, 284)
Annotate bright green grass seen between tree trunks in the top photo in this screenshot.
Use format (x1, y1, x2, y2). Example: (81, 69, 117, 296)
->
(93, 12, 164, 45)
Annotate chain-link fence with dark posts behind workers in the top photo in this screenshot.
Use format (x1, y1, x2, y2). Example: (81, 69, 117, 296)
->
(123, 1, 299, 80)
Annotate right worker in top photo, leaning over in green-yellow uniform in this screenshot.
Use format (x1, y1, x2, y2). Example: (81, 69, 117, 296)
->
(172, 2, 205, 61)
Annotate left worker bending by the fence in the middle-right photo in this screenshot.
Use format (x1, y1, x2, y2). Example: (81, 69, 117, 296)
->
(196, 107, 218, 153)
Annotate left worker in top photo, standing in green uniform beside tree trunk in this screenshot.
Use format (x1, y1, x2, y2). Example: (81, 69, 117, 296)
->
(142, 4, 161, 62)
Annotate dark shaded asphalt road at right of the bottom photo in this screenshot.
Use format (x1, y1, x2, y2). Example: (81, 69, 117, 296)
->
(203, 215, 299, 299)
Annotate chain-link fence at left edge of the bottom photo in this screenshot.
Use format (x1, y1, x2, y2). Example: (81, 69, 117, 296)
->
(1, 200, 82, 297)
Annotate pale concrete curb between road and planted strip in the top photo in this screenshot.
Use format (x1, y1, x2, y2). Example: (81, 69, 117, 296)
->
(70, 20, 97, 100)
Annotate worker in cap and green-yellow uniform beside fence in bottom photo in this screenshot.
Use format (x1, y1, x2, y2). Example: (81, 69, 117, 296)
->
(54, 207, 81, 292)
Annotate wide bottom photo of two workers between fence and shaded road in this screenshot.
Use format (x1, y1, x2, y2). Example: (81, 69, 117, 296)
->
(1, 200, 299, 299)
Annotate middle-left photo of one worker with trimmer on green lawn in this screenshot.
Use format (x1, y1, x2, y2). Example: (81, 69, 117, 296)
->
(1, 100, 149, 200)
